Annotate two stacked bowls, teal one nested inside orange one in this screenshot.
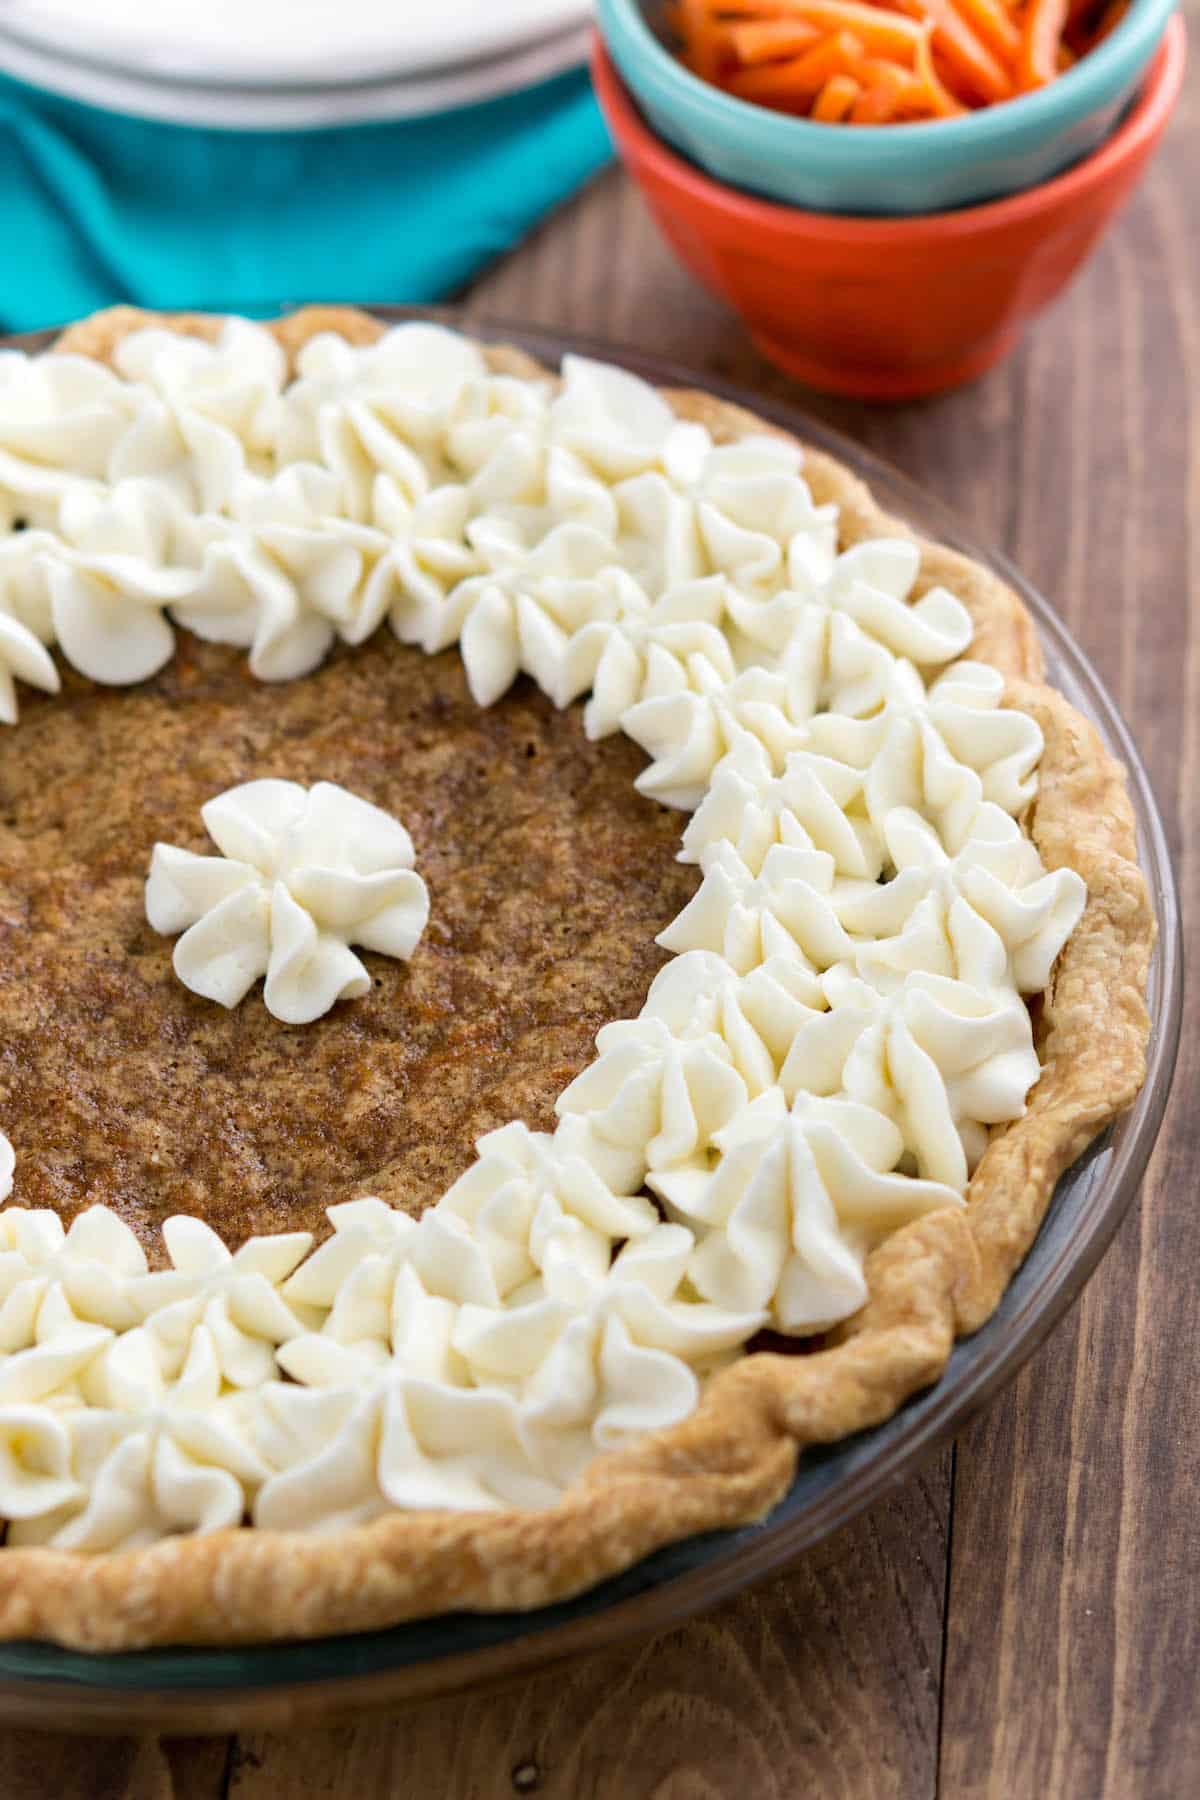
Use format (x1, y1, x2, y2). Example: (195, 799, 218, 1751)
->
(594, 0, 1186, 400)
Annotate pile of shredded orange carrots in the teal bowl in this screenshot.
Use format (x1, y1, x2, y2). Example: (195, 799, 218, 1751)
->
(664, 0, 1130, 124)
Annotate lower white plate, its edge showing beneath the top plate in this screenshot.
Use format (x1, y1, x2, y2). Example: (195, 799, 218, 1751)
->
(0, 20, 590, 131)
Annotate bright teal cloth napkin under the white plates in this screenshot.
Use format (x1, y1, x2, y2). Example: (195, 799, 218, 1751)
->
(0, 70, 612, 331)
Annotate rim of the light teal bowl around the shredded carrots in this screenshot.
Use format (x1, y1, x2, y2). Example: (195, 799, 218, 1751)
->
(597, 0, 1178, 153)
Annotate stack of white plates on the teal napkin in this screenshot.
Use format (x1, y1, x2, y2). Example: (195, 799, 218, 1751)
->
(0, 0, 592, 131)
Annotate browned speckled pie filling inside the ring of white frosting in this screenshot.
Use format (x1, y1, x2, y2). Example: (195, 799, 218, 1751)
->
(0, 630, 698, 1255)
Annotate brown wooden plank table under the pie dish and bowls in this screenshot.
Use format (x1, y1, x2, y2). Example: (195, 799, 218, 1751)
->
(0, 21, 1200, 1800)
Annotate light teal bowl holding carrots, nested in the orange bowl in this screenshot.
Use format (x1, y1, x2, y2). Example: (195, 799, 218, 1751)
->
(596, 0, 1175, 216)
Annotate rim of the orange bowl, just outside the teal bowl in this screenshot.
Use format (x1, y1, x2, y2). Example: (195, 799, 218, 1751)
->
(592, 14, 1187, 235)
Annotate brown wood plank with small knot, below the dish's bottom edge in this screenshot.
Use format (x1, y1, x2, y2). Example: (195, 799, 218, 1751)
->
(230, 1467, 946, 1800)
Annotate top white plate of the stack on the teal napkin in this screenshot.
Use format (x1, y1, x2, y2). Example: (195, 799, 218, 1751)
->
(0, 0, 592, 88)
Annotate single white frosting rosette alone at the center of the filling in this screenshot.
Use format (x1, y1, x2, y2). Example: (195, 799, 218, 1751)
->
(146, 779, 428, 1024)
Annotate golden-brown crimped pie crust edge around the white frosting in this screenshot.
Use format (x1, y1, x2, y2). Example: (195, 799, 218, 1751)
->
(0, 308, 1155, 1651)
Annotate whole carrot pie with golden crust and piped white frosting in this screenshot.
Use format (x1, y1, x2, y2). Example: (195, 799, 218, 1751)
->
(0, 308, 1153, 1651)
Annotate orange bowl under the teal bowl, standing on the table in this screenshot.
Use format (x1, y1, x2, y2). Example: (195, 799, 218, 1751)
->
(592, 18, 1186, 400)
